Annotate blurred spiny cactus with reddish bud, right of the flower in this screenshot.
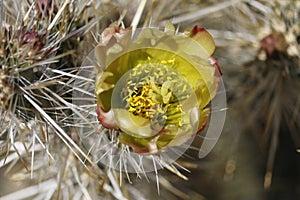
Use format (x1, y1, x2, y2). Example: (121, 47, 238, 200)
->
(218, 1, 300, 194)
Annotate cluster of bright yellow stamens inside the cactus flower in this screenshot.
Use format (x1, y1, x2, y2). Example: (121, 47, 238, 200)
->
(123, 63, 189, 127)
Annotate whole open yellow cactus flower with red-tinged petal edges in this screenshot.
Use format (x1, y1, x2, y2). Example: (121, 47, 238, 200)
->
(95, 24, 219, 153)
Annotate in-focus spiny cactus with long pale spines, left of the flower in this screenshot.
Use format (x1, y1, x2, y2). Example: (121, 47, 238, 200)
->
(0, 1, 131, 199)
